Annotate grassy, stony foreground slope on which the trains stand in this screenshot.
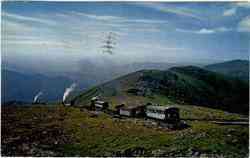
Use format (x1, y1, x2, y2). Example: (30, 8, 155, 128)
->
(2, 104, 249, 157)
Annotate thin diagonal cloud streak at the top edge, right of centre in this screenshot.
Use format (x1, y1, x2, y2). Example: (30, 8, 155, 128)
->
(138, 3, 204, 20)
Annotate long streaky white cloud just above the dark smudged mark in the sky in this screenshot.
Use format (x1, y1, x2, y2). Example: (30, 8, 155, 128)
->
(52, 11, 168, 37)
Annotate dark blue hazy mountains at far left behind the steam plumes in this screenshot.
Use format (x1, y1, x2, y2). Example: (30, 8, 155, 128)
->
(1, 70, 73, 103)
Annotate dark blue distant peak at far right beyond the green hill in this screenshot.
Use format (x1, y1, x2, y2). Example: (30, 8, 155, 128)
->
(204, 60, 249, 82)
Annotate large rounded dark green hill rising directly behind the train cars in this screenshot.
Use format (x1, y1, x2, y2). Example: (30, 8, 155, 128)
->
(75, 66, 249, 114)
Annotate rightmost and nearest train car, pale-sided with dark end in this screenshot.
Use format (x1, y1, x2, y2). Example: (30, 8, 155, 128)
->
(146, 106, 180, 123)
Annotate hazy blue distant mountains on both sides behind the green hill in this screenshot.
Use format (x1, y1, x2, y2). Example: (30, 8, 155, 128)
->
(2, 60, 249, 105)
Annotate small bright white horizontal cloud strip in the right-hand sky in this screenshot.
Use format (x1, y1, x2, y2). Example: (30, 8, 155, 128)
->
(176, 27, 232, 34)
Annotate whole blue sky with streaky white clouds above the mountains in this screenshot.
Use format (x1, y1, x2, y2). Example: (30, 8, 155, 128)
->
(1, 1, 250, 73)
